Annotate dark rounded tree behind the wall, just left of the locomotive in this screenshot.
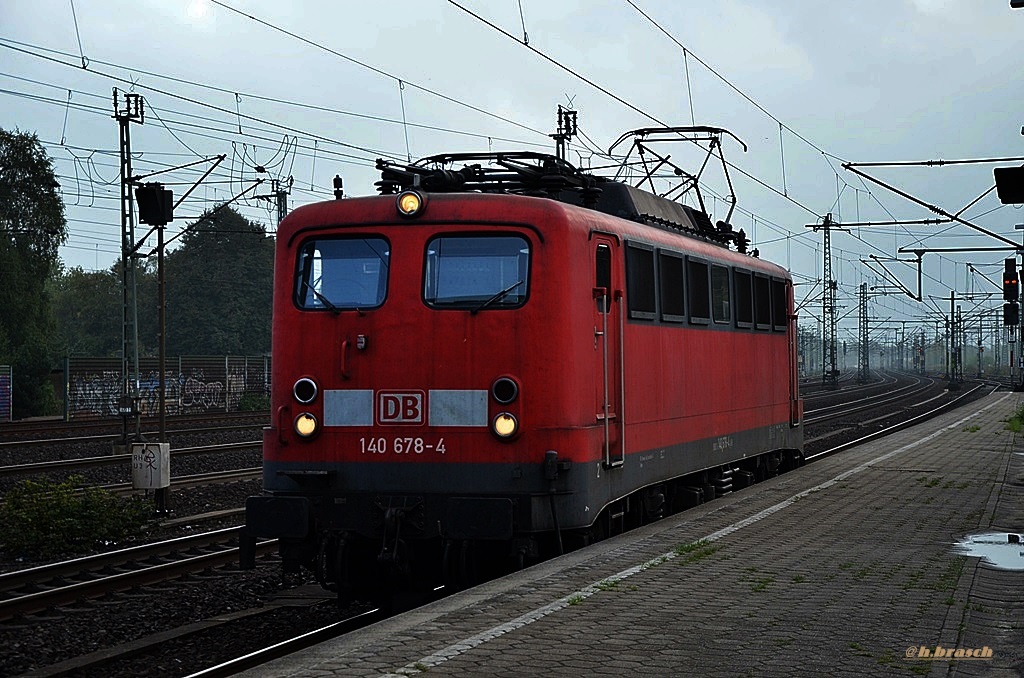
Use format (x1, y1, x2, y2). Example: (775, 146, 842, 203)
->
(165, 207, 273, 355)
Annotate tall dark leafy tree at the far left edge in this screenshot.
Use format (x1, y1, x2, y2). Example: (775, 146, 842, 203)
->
(0, 129, 68, 418)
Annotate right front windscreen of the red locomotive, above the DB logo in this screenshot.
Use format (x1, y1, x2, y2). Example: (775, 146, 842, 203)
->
(423, 236, 529, 313)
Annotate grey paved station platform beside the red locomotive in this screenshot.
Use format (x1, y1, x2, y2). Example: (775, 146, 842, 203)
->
(244, 393, 1024, 677)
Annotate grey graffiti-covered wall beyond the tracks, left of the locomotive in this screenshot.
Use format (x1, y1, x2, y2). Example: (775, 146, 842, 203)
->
(65, 355, 270, 419)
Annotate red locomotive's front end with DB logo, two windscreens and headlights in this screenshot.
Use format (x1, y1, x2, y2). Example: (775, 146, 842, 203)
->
(241, 192, 589, 598)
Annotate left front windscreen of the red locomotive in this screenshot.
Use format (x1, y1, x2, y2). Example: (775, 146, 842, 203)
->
(295, 238, 391, 310)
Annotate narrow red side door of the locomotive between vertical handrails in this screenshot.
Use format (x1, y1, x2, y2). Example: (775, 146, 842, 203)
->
(592, 235, 626, 467)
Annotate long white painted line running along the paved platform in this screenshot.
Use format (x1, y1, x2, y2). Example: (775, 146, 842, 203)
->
(384, 393, 1013, 678)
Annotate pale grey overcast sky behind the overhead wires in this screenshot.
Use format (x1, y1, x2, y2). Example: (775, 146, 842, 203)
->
(0, 0, 1024, 340)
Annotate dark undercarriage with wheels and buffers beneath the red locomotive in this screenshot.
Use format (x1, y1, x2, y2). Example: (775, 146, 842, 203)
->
(253, 450, 803, 601)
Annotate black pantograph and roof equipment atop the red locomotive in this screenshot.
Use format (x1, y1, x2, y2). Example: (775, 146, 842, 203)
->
(376, 127, 757, 256)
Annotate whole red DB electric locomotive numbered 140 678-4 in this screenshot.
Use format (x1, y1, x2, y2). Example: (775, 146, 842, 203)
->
(246, 147, 803, 591)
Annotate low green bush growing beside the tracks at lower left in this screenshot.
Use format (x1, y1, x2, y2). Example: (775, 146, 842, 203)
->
(0, 476, 153, 560)
